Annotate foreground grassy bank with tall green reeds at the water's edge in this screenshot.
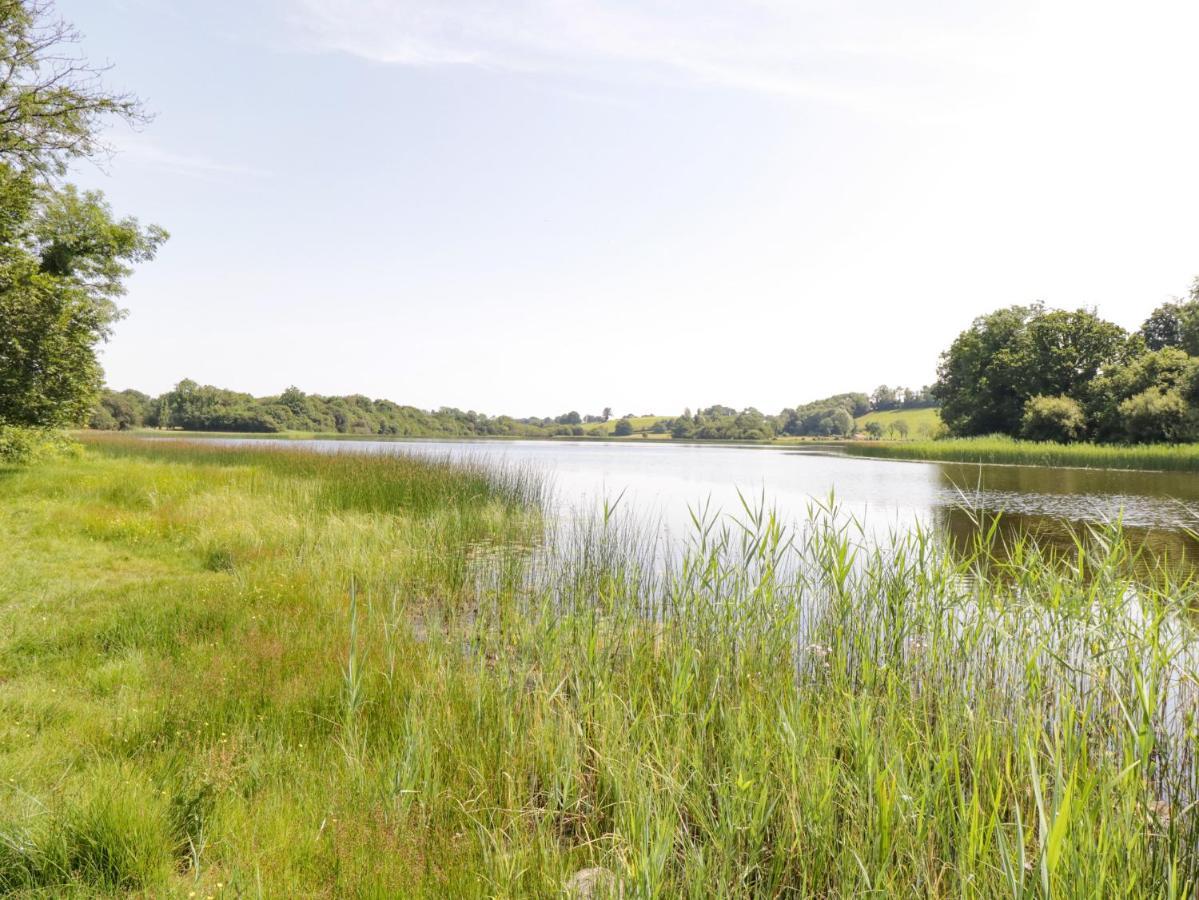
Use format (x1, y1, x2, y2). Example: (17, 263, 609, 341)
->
(0, 440, 1199, 898)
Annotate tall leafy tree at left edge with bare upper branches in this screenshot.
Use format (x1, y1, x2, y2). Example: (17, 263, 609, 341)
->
(0, 0, 167, 428)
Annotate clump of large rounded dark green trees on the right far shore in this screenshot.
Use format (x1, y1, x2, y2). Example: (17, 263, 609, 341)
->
(932, 278, 1199, 443)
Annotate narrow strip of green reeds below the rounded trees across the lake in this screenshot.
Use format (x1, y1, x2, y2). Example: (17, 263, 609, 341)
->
(839, 436, 1199, 472)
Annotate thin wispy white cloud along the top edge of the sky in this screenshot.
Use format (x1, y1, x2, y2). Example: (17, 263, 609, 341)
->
(282, 0, 1018, 107)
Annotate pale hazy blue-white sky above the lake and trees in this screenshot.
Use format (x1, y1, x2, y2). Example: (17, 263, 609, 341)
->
(58, 0, 1199, 416)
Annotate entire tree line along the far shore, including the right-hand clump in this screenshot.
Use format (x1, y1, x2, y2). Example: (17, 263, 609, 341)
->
(89, 278, 1199, 443)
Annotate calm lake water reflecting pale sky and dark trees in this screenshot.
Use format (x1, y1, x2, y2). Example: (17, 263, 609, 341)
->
(223, 439, 1199, 561)
